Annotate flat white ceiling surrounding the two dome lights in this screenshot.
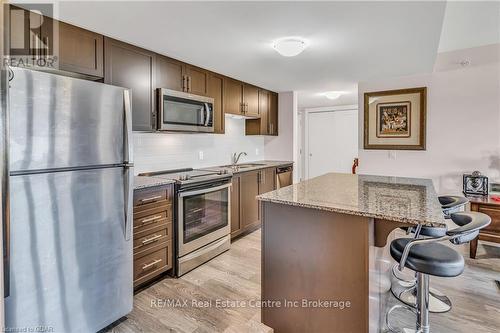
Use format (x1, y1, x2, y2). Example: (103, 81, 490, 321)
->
(40, 1, 445, 107)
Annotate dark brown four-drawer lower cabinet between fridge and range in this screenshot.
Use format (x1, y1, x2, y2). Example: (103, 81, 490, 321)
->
(133, 185, 174, 288)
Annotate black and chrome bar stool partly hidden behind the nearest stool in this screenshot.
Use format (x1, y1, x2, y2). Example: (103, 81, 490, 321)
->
(391, 196, 469, 313)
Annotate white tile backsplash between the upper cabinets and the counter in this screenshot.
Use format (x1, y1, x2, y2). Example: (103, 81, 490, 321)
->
(134, 117, 264, 174)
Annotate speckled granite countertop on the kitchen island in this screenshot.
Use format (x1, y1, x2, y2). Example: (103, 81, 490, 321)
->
(257, 173, 446, 227)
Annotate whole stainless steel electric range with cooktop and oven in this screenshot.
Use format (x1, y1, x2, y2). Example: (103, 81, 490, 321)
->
(140, 169, 232, 276)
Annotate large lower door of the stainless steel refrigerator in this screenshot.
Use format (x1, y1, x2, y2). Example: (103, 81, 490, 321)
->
(5, 168, 133, 332)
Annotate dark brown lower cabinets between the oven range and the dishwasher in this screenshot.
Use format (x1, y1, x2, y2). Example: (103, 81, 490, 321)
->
(231, 168, 276, 238)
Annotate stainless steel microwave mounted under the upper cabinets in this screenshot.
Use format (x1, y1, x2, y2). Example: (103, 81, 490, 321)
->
(157, 88, 214, 133)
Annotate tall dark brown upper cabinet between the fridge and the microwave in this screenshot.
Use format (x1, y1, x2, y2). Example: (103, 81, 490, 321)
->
(104, 37, 156, 131)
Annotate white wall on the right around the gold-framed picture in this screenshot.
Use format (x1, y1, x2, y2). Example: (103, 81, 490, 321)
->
(358, 48, 500, 194)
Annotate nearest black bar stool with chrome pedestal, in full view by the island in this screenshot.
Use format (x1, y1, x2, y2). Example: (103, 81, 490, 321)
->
(386, 212, 491, 333)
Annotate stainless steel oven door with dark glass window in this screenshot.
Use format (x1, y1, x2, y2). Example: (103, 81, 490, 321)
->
(177, 183, 231, 257)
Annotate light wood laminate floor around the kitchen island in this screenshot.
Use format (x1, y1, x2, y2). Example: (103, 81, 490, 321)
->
(108, 230, 500, 333)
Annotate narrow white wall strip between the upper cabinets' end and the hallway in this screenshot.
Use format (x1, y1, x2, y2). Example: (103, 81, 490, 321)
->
(264, 91, 299, 181)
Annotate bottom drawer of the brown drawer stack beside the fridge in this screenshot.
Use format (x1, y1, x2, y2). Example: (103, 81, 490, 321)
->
(134, 241, 172, 287)
